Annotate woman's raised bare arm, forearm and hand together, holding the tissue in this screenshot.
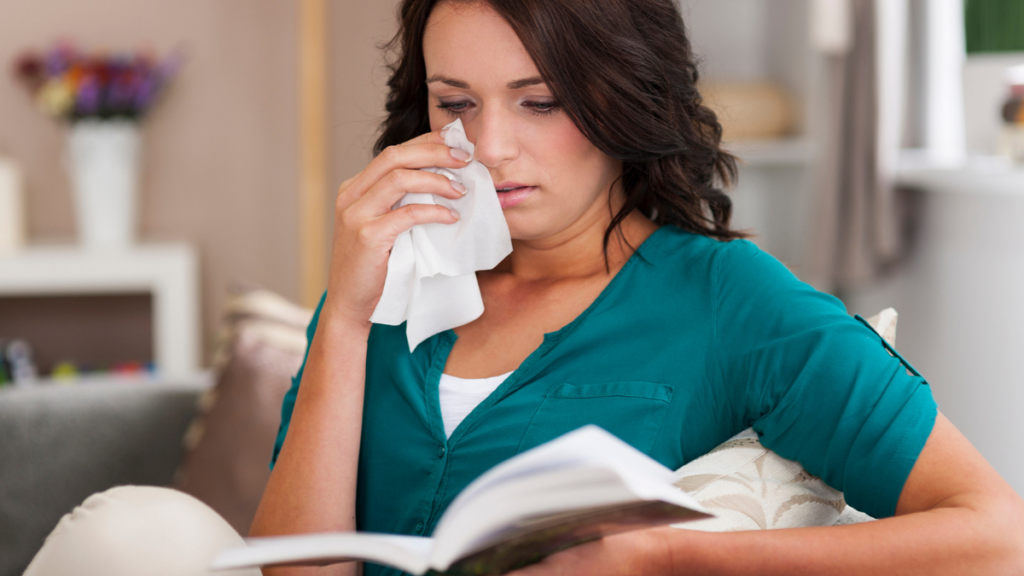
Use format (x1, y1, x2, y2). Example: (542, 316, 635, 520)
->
(256, 132, 469, 576)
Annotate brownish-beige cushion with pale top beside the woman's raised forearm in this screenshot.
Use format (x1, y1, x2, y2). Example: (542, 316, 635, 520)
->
(176, 290, 312, 534)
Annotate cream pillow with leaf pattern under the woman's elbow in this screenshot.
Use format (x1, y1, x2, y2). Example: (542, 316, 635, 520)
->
(674, 308, 897, 532)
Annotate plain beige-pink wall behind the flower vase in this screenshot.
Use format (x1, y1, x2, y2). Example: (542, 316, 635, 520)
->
(0, 0, 394, 361)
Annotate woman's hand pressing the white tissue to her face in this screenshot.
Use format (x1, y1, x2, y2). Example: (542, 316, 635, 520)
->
(324, 131, 470, 326)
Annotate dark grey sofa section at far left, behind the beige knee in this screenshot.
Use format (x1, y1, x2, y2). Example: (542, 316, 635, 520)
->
(0, 384, 201, 576)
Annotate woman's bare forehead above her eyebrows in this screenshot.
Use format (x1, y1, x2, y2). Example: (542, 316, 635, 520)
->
(423, 1, 538, 83)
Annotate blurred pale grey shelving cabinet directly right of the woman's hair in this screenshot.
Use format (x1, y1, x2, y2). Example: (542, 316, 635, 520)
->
(679, 0, 824, 268)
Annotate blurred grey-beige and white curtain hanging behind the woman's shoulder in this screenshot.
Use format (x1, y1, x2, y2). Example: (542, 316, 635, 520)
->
(805, 0, 964, 293)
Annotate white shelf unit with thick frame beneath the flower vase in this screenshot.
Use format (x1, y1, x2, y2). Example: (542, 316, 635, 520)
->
(0, 244, 199, 376)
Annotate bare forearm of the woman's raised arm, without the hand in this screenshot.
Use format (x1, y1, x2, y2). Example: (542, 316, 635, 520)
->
(250, 307, 370, 574)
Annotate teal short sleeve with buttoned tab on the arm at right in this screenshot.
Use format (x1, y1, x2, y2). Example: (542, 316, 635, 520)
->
(714, 240, 937, 518)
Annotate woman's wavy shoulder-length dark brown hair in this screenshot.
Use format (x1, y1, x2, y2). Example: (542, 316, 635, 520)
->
(374, 0, 744, 261)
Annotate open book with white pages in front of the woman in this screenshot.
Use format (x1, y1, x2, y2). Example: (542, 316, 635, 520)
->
(213, 425, 711, 575)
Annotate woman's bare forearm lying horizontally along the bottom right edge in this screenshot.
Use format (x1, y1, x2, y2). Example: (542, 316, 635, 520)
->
(650, 498, 1024, 576)
